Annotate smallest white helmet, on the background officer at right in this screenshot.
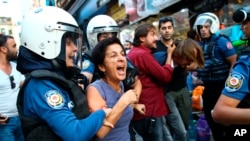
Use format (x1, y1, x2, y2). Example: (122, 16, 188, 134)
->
(193, 12, 220, 34)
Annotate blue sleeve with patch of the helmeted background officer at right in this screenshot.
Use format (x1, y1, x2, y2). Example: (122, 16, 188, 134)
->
(215, 37, 236, 58)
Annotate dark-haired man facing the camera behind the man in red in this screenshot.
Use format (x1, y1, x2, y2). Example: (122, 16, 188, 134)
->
(153, 16, 190, 141)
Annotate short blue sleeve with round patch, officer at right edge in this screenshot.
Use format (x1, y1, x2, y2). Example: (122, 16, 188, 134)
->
(222, 58, 250, 100)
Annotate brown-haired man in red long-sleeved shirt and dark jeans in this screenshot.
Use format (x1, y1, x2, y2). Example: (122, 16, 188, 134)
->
(127, 24, 175, 141)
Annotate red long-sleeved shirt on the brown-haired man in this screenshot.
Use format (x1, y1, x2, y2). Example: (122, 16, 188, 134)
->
(127, 46, 173, 120)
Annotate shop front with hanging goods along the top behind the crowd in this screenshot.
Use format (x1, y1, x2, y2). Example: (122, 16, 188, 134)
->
(66, 0, 250, 47)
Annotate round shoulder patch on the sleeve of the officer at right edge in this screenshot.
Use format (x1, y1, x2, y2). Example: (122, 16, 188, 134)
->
(225, 72, 244, 92)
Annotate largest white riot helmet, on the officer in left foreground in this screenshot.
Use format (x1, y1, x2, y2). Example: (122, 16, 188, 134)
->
(21, 6, 82, 61)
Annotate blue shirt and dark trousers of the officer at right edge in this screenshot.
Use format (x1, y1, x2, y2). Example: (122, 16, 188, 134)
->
(222, 54, 250, 141)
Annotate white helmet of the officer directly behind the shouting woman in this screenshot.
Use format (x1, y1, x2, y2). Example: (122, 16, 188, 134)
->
(86, 15, 120, 48)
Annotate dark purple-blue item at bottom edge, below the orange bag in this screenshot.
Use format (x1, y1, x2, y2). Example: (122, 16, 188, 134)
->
(196, 113, 211, 141)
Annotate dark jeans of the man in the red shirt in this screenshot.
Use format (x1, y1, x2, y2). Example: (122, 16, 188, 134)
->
(131, 116, 173, 141)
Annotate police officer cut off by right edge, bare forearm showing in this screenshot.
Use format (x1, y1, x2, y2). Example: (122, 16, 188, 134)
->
(213, 6, 250, 141)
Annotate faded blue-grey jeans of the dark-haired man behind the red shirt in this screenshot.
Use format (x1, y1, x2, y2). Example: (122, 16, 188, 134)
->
(165, 93, 187, 141)
